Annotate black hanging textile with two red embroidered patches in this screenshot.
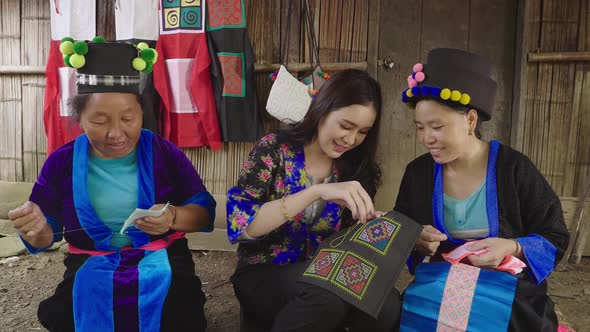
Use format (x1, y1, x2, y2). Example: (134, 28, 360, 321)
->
(207, 0, 264, 142)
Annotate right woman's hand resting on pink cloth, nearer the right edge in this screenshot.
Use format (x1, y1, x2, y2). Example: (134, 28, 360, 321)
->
(467, 237, 518, 269)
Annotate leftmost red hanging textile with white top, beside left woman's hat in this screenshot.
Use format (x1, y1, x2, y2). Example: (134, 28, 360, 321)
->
(43, 0, 96, 155)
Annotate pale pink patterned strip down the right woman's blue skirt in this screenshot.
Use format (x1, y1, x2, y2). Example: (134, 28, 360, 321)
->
(436, 264, 481, 332)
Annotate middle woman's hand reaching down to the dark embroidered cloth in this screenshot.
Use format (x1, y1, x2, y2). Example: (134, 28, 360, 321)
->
(315, 181, 375, 224)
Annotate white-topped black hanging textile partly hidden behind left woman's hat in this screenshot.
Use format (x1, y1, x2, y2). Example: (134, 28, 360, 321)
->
(115, 0, 160, 133)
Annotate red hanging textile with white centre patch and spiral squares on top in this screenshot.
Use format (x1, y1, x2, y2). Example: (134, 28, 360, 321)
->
(154, 0, 221, 150)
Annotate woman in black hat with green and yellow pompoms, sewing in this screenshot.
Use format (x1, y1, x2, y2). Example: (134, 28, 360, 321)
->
(10, 39, 215, 331)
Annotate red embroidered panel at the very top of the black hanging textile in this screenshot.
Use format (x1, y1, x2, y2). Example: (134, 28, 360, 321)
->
(207, 0, 246, 30)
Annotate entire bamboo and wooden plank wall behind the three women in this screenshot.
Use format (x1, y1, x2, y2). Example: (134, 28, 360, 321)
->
(0, 0, 590, 208)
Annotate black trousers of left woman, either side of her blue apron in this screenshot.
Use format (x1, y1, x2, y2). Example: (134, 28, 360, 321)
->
(37, 239, 207, 332)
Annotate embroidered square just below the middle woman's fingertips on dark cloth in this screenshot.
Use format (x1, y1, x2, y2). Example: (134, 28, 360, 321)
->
(352, 217, 401, 255)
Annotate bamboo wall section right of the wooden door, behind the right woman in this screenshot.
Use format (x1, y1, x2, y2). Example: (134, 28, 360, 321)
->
(512, 0, 590, 196)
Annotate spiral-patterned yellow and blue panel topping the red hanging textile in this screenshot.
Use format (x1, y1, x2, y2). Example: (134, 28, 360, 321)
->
(160, 0, 205, 34)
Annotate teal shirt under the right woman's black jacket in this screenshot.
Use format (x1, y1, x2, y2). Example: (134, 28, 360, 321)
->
(444, 180, 490, 240)
